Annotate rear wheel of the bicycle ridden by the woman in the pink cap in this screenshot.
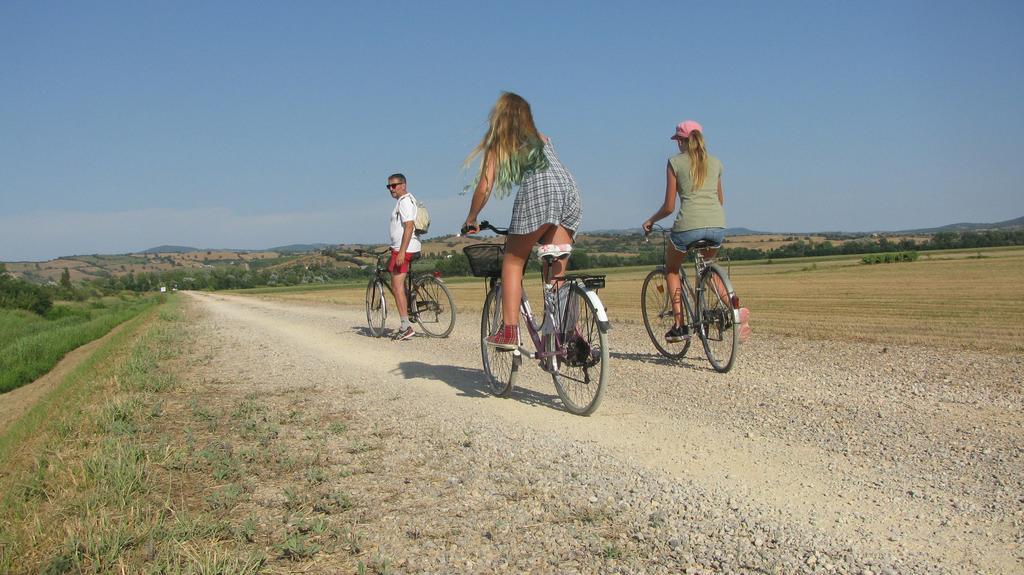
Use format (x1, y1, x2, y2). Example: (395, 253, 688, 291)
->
(697, 266, 739, 373)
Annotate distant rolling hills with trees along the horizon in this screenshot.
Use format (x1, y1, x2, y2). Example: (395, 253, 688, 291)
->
(4, 217, 1024, 282)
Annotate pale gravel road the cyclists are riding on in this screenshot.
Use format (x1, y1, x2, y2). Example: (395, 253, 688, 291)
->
(188, 293, 1024, 573)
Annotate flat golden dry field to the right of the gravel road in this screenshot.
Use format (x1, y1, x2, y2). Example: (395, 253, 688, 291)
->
(262, 249, 1024, 354)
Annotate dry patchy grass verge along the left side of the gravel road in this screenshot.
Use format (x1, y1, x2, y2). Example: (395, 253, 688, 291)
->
(0, 297, 392, 575)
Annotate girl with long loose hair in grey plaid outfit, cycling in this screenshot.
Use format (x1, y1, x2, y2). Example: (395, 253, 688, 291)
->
(463, 92, 582, 349)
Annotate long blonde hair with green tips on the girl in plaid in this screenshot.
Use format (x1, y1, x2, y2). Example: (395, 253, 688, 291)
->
(463, 92, 549, 197)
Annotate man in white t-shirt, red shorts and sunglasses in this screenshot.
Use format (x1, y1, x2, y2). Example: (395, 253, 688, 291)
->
(387, 174, 421, 341)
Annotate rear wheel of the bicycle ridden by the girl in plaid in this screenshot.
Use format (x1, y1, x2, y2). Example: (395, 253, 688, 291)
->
(551, 284, 608, 415)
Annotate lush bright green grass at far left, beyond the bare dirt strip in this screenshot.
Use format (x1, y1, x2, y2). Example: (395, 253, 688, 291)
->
(0, 296, 159, 393)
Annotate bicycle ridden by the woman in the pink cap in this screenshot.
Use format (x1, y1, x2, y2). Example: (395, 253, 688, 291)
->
(640, 224, 740, 373)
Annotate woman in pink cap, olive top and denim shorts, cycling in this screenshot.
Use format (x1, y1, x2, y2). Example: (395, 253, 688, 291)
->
(642, 120, 725, 342)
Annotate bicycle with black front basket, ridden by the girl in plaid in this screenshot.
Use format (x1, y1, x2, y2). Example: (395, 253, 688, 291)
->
(463, 222, 611, 415)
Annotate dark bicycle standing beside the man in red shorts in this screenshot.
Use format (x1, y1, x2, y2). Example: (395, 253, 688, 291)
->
(357, 250, 456, 338)
